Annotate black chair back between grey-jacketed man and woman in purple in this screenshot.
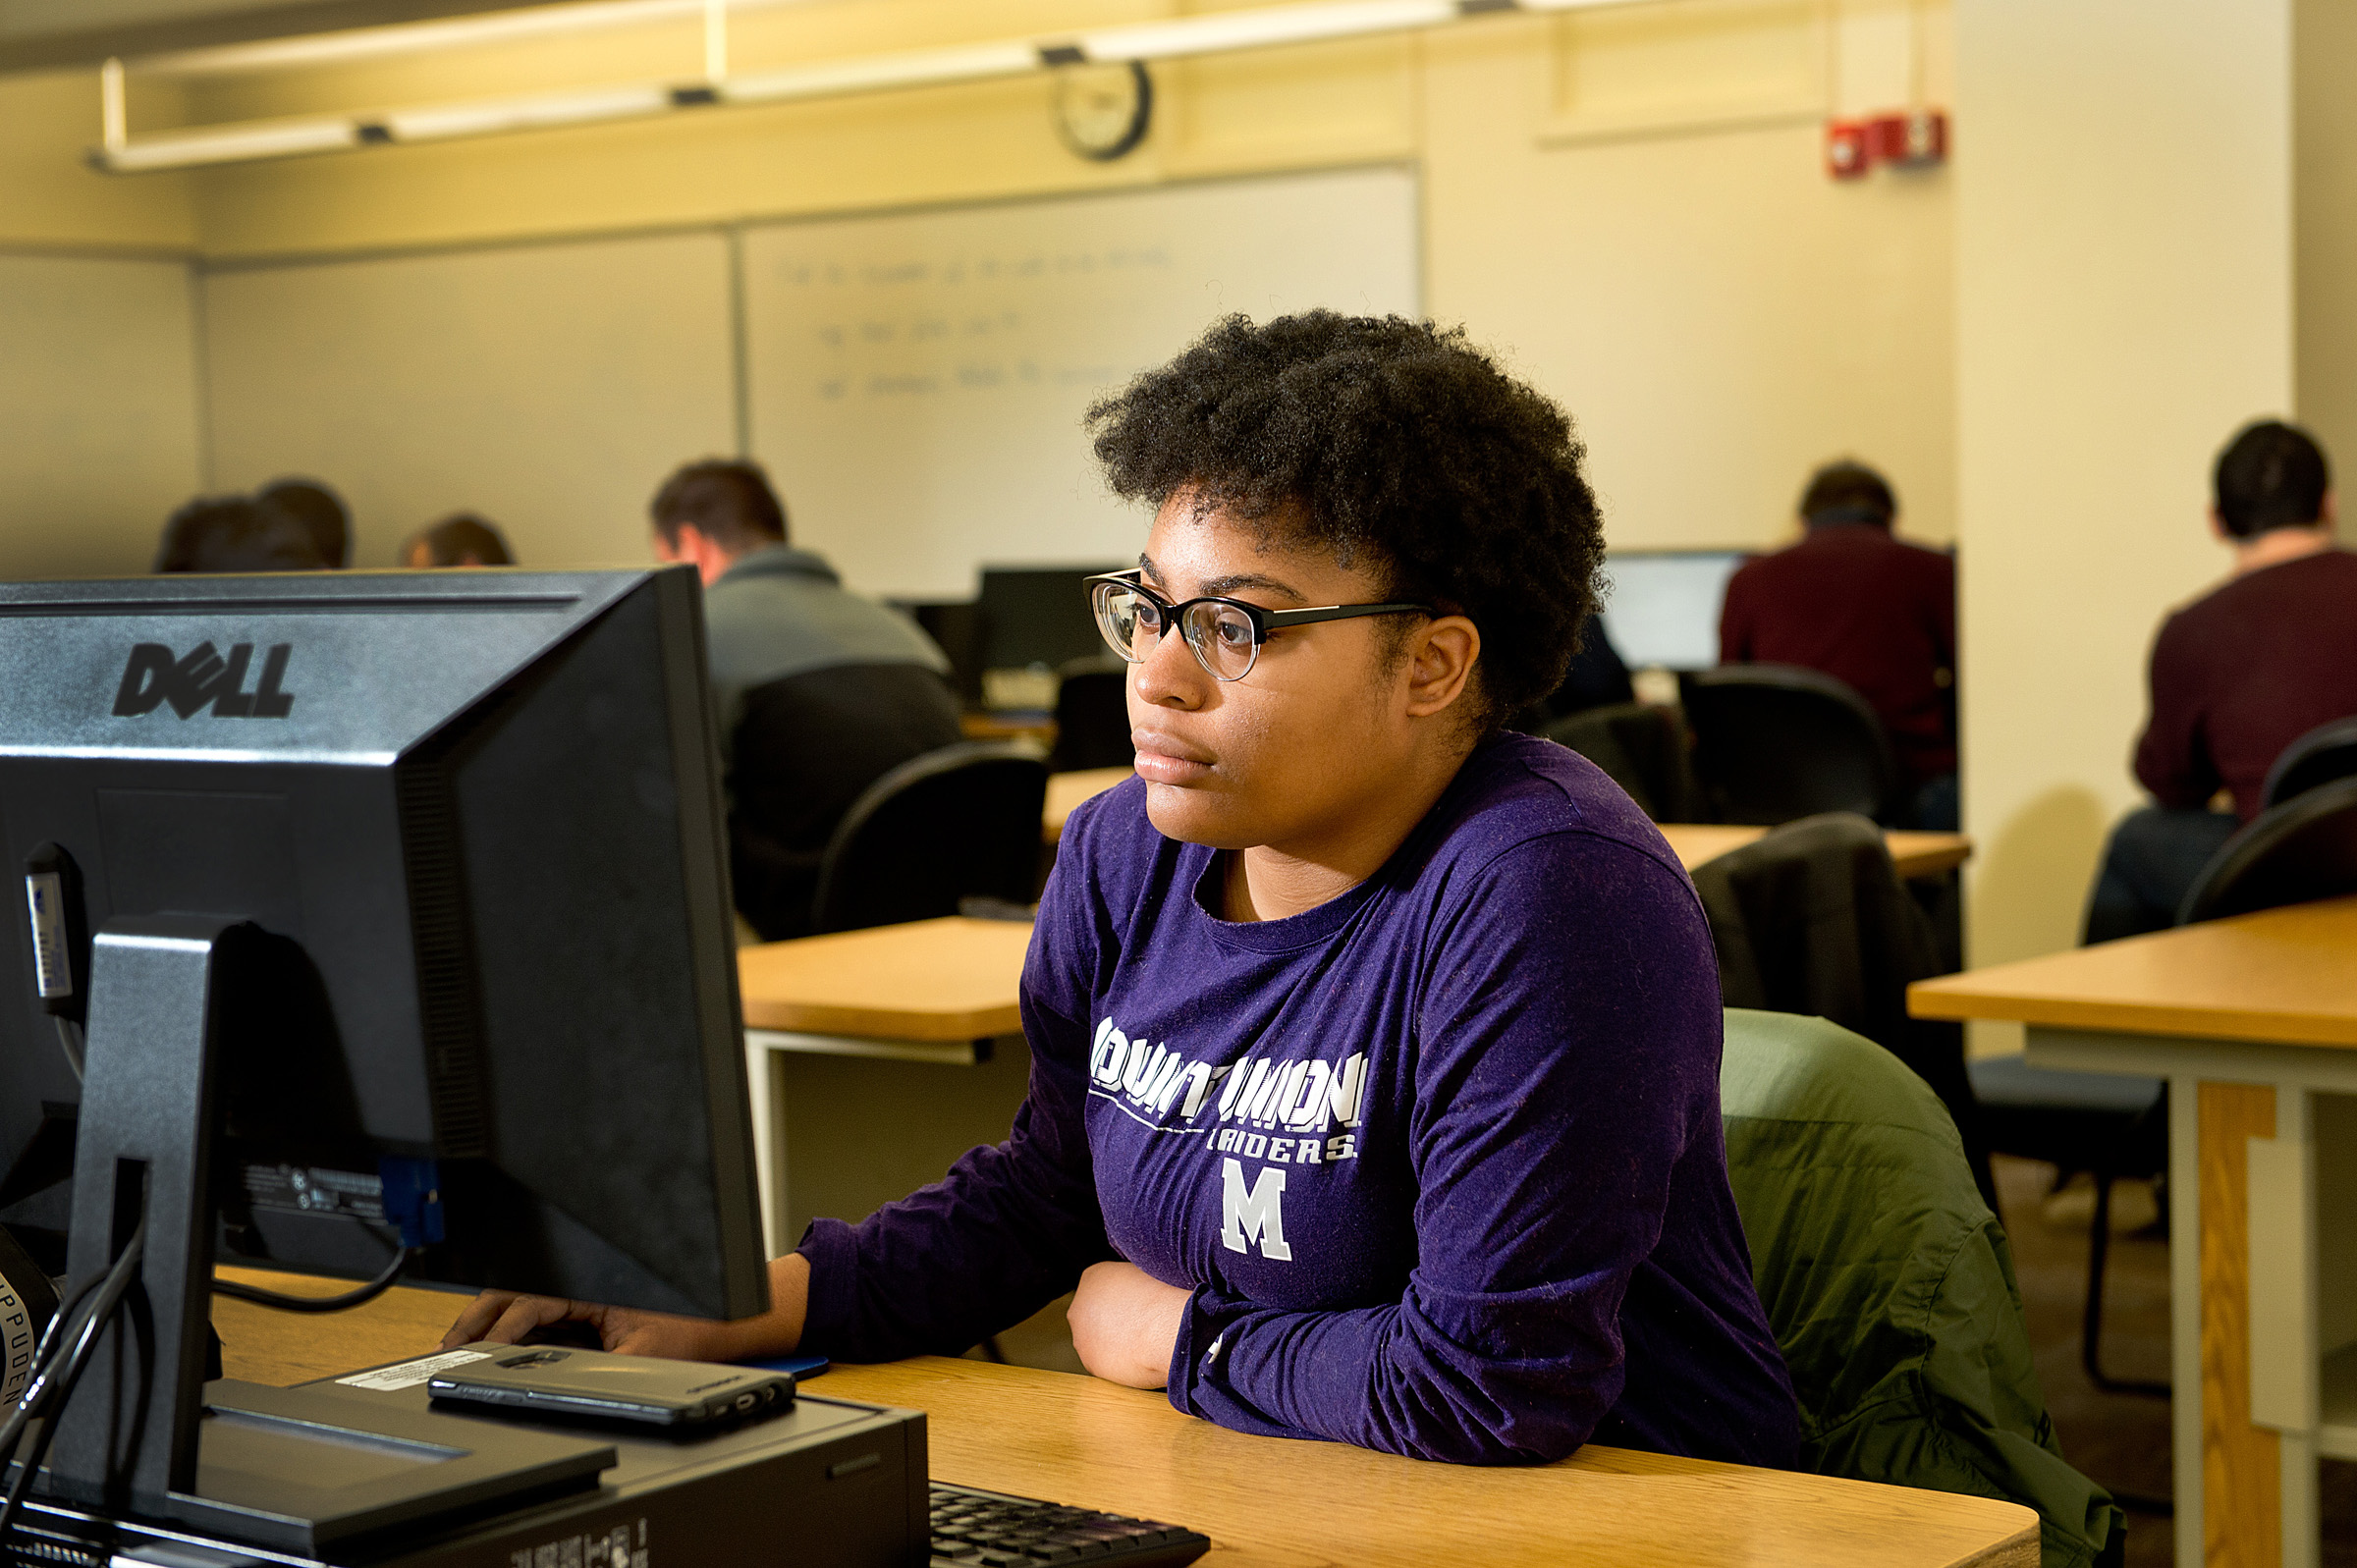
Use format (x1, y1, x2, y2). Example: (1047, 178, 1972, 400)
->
(811, 740, 1047, 934)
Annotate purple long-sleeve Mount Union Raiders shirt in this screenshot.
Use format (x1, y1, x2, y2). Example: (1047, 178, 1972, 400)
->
(801, 735, 1798, 1464)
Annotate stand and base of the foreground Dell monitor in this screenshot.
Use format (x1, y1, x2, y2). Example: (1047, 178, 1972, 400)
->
(35, 915, 615, 1551)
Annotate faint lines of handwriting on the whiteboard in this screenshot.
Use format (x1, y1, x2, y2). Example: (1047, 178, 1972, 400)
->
(776, 245, 1172, 404)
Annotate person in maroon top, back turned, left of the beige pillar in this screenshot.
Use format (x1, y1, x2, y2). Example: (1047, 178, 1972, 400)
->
(1719, 462, 1956, 833)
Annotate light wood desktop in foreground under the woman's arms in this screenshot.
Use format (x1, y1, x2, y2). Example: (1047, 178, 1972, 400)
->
(212, 1269, 2039, 1568)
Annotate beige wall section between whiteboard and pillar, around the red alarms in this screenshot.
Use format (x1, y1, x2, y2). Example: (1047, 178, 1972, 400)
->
(1424, 5, 1956, 547)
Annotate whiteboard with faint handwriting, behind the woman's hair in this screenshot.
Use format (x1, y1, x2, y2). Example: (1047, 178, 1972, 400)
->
(744, 168, 1419, 599)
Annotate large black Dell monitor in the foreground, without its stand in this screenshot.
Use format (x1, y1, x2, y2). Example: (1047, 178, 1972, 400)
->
(0, 568, 766, 1316)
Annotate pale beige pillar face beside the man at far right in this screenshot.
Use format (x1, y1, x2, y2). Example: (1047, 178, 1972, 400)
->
(1956, 0, 2293, 990)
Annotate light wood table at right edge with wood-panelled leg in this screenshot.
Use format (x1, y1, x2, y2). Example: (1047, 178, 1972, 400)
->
(1907, 898, 2357, 1568)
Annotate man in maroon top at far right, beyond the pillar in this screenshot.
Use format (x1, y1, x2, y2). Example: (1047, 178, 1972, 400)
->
(2086, 419, 2357, 941)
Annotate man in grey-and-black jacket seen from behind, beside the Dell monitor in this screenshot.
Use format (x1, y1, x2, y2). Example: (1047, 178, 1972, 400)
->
(653, 460, 964, 941)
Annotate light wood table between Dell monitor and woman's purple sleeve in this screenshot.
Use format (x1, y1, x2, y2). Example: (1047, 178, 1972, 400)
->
(738, 917, 1030, 1252)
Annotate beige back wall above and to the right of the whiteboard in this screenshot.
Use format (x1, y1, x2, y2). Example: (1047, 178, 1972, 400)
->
(106, 0, 1954, 559)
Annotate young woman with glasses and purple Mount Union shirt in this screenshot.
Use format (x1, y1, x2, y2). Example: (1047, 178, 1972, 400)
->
(450, 313, 1796, 1464)
